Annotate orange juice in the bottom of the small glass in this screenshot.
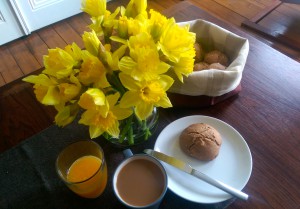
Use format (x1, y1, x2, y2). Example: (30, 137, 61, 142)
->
(67, 155, 107, 198)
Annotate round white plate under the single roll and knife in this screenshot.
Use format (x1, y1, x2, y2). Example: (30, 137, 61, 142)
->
(154, 115, 252, 203)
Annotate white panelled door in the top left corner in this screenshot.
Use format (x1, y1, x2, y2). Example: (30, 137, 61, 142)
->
(0, 0, 109, 45)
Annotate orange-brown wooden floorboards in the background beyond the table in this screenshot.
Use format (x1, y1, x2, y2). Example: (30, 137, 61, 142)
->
(0, 0, 300, 86)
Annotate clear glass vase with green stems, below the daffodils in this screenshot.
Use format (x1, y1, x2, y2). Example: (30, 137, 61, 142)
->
(106, 107, 158, 147)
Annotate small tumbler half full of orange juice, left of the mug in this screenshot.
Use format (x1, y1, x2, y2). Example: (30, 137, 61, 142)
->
(56, 140, 107, 198)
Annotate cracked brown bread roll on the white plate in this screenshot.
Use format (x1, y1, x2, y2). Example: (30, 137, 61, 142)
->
(179, 123, 222, 161)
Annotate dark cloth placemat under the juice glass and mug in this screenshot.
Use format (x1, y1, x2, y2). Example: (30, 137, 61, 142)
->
(0, 117, 234, 209)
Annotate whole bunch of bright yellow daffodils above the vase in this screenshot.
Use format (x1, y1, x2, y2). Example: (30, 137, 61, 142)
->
(23, 0, 195, 143)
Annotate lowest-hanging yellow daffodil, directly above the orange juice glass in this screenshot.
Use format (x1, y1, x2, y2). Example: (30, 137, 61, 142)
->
(79, 93, 132, 138)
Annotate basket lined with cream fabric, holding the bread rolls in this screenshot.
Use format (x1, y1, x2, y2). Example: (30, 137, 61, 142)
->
(168, 19, 249, 106)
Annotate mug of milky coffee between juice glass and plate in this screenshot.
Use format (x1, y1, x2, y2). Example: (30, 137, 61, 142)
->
(113, 149, 168, 209)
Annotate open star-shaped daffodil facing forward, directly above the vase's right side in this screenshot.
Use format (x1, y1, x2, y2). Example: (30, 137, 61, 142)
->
(119, 73, 174, 120)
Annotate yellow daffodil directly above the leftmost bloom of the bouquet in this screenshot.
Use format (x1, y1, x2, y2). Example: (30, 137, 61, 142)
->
(43, 48, 77, 79)
